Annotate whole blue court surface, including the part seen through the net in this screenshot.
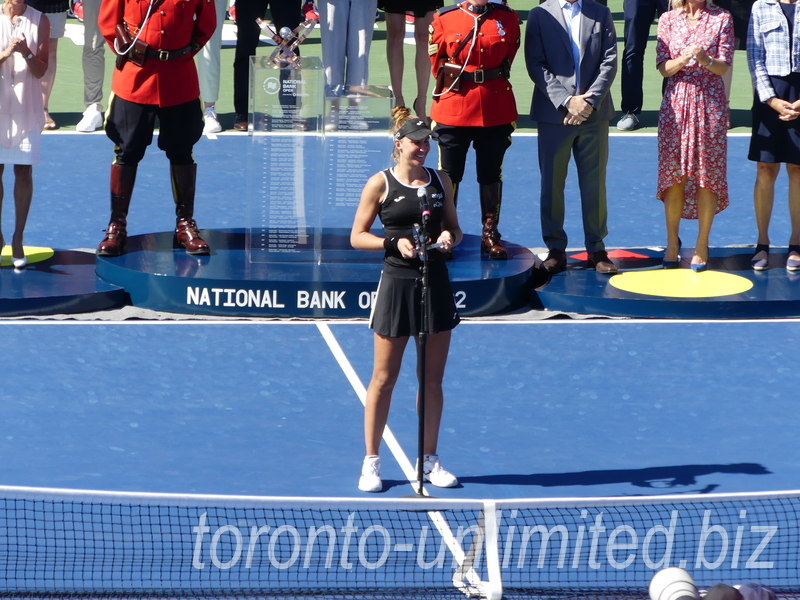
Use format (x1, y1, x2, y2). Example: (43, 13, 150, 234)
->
(0, 127, 800, 598)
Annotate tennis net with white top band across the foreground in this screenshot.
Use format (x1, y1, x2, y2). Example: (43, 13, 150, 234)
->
(0, 487, 800, 600)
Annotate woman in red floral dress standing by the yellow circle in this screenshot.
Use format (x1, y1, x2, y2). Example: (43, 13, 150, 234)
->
(656, 0, 733, 271)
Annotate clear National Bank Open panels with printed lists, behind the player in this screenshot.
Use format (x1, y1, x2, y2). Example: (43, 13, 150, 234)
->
(246, 56, 393, 263)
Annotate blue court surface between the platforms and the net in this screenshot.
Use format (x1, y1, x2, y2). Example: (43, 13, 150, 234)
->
(0, 321, 800, 498)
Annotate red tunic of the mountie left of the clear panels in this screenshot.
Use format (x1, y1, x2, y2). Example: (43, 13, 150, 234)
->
(98, 0, 217, 107)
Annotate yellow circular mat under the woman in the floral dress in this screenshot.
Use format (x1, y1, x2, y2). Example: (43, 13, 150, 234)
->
(609, 269, 753, 298)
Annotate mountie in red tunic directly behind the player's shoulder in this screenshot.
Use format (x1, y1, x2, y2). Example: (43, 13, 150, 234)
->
(428, 0, 520, 259)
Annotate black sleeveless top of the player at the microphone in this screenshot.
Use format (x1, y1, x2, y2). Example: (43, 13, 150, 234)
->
(378, 167, 444, 277)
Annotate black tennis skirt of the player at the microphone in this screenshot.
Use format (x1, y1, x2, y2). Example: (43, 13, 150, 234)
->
(369, 263, 460, 337)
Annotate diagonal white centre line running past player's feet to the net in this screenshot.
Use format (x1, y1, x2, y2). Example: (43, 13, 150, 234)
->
(317, 323, 481, 587)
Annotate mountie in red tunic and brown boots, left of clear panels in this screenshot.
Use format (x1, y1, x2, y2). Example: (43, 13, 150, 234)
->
(97, 0, 217, 256)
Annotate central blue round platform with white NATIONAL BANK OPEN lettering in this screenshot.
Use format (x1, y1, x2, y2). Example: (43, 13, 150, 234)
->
(97, 229, 535, 318)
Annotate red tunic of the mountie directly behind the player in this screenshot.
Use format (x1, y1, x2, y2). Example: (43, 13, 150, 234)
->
(428, 2, 520, 127)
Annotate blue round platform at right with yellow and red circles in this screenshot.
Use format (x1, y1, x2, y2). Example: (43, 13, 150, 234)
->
(531, 248, 800, 319)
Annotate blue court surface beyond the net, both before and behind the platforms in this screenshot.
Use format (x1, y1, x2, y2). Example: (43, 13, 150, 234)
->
(0, 133, 798, 498)
